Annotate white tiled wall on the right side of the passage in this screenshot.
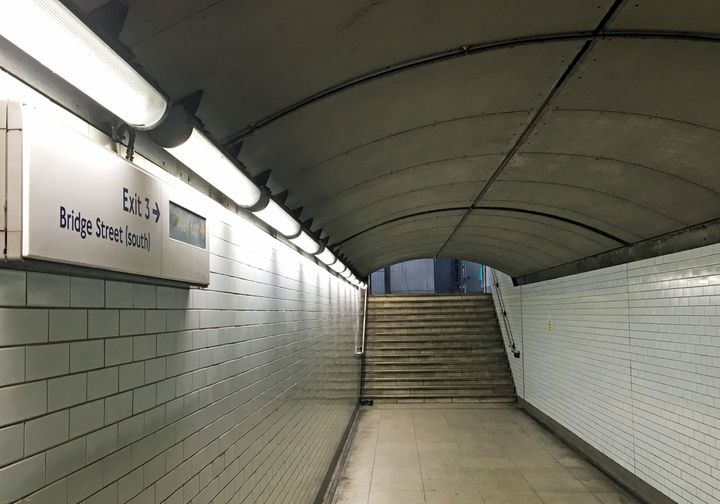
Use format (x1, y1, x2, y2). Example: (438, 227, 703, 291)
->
(492, 245, 720, 504)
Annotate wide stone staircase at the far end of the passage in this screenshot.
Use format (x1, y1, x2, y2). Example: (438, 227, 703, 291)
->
(362, 295, 515, 402)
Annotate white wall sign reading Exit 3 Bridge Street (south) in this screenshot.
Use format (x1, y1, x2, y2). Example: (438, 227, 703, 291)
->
(9, 104, 209, 284)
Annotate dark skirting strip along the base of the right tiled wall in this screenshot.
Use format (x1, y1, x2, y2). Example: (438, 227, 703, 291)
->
(517, 397, 677, 504)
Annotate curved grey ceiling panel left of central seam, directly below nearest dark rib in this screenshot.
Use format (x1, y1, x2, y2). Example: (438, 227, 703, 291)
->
(239, 41, 580, 175)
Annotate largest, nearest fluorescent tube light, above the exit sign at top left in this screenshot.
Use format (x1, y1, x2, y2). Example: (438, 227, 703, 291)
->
(0, 0, 168, 129)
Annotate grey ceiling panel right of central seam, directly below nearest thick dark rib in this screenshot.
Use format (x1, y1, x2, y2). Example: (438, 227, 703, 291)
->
(553, 39, 720, 129)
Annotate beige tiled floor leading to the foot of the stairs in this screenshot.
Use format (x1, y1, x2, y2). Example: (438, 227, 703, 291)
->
(336, 405, 639, 504)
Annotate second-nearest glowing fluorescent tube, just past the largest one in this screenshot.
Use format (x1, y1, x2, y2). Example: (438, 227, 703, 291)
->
(166, 128, 260, 207)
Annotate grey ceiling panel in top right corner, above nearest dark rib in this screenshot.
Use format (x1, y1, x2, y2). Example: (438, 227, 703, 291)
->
(608, 0, 720, 33)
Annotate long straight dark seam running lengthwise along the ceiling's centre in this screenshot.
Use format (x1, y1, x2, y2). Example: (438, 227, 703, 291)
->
(435, 0, 624, 257)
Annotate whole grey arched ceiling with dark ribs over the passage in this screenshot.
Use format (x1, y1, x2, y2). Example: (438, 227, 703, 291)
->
(75, 0, 720, 276)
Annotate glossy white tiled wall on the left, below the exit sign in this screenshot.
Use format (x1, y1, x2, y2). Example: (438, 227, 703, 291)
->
(0, 210, 359, 504)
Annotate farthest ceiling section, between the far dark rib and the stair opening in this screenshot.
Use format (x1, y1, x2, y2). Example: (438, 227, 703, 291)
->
(342, 206, 619, 275)
